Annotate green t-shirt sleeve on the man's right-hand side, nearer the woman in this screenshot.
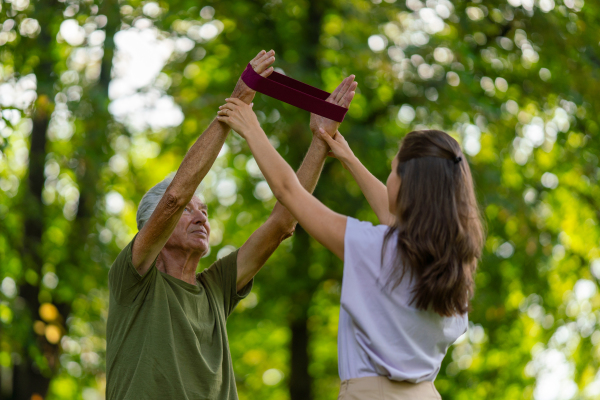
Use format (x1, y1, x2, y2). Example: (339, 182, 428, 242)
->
(200, 249, 254, 318)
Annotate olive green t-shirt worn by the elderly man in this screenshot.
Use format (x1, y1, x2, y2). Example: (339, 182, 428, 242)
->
(106, 238, 252, 400)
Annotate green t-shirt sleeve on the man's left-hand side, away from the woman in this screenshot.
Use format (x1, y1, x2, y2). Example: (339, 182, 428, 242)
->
(108, 235, 157, 306)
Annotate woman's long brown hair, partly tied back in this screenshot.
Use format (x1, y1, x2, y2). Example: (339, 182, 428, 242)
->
(381, 130, 485, 316)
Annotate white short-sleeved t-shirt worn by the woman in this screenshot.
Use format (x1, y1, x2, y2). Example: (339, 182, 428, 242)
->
(338, 217, 468, 383)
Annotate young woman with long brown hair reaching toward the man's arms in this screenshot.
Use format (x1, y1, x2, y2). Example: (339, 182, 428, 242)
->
(218, 99, 484, 400)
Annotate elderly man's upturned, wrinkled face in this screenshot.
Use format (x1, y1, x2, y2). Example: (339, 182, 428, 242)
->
(165, 196, 210, 255)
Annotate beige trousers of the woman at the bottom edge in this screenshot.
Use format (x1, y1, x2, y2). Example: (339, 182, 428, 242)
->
(338, 376, 442, 400)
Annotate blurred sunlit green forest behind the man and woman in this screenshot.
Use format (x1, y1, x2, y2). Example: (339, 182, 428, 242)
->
(0, 0, 600, 400)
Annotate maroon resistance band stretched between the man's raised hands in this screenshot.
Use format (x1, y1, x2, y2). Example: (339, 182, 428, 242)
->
(242, 64, 348, 122)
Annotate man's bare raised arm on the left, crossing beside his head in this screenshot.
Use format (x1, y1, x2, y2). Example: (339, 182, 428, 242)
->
(132, 50, 275, 275)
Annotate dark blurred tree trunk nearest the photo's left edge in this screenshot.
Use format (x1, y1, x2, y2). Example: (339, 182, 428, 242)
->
(8, 1, 58, 394)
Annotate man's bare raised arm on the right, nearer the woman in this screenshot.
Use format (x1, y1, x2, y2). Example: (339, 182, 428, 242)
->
(236, 75, 356, 291)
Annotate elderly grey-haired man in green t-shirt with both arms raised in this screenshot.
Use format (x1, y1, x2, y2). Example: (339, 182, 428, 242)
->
(106, 50, 356, 400)
